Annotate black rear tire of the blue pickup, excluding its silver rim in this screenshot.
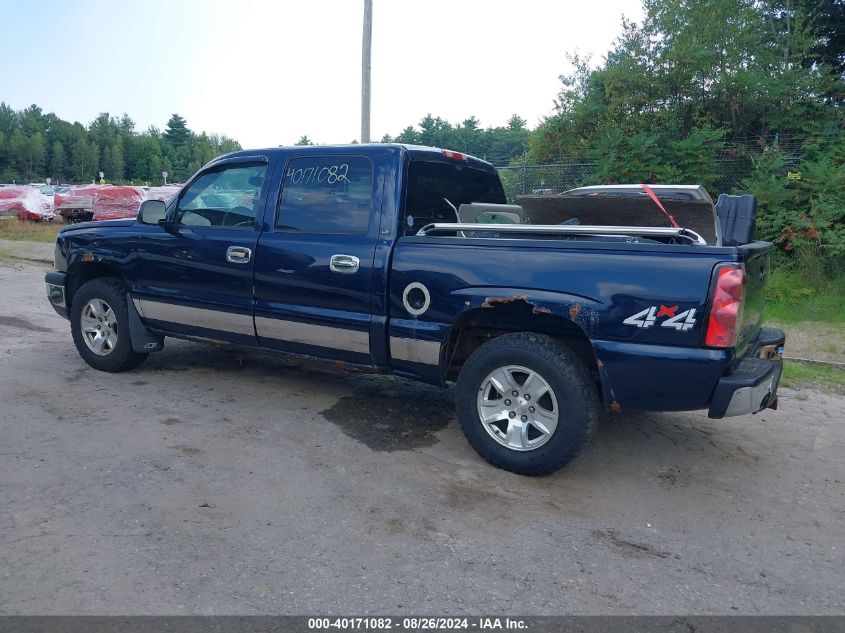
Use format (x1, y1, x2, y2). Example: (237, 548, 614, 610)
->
(455, 332, 599, 476)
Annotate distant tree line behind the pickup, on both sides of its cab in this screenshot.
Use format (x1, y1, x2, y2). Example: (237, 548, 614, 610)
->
(0, 103, 531, 183)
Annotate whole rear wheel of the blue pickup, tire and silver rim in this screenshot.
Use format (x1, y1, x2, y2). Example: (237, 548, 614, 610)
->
(456, 333, 599, 475)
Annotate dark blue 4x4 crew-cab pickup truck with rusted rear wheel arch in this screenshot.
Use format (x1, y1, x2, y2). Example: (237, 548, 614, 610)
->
(46, 144, 784, 475)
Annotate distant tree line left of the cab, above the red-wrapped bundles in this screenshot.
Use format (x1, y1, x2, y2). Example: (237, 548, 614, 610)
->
(0, 103, 241, 184)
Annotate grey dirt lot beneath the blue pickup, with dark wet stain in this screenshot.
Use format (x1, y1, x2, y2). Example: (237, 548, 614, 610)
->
(0, 262, 845, 615)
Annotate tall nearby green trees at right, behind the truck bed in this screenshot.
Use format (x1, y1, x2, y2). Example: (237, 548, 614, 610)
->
(528, 0, 845, 272)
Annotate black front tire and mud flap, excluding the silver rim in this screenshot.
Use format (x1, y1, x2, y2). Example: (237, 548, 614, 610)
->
(70, 277, 147, 373)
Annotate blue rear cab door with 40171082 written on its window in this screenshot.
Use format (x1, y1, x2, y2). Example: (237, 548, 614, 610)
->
(255, 152, 380, 364)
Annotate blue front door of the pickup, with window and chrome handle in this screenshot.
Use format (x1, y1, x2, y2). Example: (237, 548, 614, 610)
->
(133, 156, 269, 345)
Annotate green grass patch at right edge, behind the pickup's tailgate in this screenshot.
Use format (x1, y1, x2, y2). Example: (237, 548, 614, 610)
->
(763, 268, 845, 323)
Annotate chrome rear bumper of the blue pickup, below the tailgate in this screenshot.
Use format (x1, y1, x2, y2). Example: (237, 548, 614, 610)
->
(707, 328, 785, 418)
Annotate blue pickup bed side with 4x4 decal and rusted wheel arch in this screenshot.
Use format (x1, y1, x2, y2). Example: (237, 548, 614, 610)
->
(390, 231, 771, 410)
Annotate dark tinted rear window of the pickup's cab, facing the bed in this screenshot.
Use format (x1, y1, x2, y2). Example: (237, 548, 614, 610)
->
(402, 160, 506, 235)
